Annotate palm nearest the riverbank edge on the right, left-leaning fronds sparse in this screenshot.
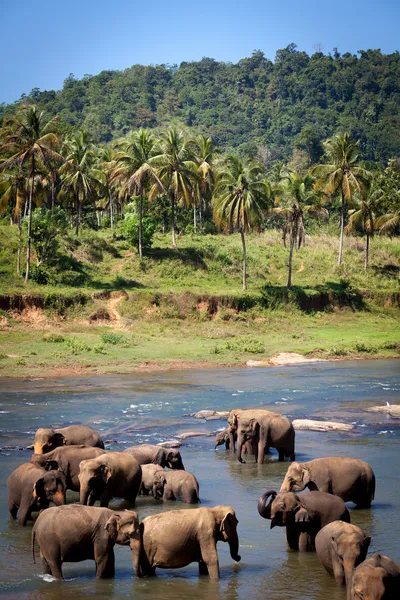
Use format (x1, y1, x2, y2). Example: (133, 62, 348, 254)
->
(274, 173, 328, 288)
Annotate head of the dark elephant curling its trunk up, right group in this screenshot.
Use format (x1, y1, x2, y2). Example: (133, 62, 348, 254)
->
(258, 490, 312, 529)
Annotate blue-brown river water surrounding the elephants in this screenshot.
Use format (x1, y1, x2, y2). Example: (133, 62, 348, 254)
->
(0, 360, 400, 600)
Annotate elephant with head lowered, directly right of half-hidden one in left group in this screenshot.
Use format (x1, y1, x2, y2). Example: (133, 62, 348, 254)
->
(79, 452, 142, 507)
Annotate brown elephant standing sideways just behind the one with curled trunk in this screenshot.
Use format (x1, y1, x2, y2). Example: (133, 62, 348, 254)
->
(280, 456, 375, 508)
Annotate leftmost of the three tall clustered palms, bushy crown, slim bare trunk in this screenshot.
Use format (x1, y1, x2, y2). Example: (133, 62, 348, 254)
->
(111, 129, 165, 258)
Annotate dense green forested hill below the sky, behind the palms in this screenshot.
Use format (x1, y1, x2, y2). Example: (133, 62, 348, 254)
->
(0, 44, 400, 163)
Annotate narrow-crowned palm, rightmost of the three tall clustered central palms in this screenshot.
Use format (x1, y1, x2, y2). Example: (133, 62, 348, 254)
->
(188, 134, 216, 233)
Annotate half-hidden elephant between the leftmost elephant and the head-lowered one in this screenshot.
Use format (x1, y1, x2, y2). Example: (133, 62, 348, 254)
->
(31, 446, 105, 492)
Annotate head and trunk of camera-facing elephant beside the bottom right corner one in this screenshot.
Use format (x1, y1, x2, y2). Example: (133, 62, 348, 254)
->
(331, 531, 371, 591)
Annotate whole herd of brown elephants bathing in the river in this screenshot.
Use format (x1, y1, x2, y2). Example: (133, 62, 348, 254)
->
(7, 409, 400, 600)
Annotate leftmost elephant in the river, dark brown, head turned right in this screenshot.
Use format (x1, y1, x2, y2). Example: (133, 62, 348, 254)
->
(7, 463, 67, 526)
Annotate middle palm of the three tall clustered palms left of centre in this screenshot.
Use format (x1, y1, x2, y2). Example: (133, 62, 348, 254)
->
(149, 127, 199, 248)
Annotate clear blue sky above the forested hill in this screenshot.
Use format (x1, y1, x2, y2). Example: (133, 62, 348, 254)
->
(0, 0, 400, 102)
